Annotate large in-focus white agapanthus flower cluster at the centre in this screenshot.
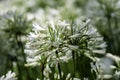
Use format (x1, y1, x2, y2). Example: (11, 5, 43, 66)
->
(25, 19, 106, 77)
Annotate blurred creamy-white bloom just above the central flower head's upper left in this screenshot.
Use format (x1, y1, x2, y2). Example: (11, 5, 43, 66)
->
(27, 8, 61, 23)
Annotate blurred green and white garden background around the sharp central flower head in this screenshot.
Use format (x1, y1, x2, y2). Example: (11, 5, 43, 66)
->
(0, 0, 120, 80)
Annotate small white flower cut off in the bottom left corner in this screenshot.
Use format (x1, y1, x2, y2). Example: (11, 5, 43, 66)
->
(0, 71, 17, 80)
